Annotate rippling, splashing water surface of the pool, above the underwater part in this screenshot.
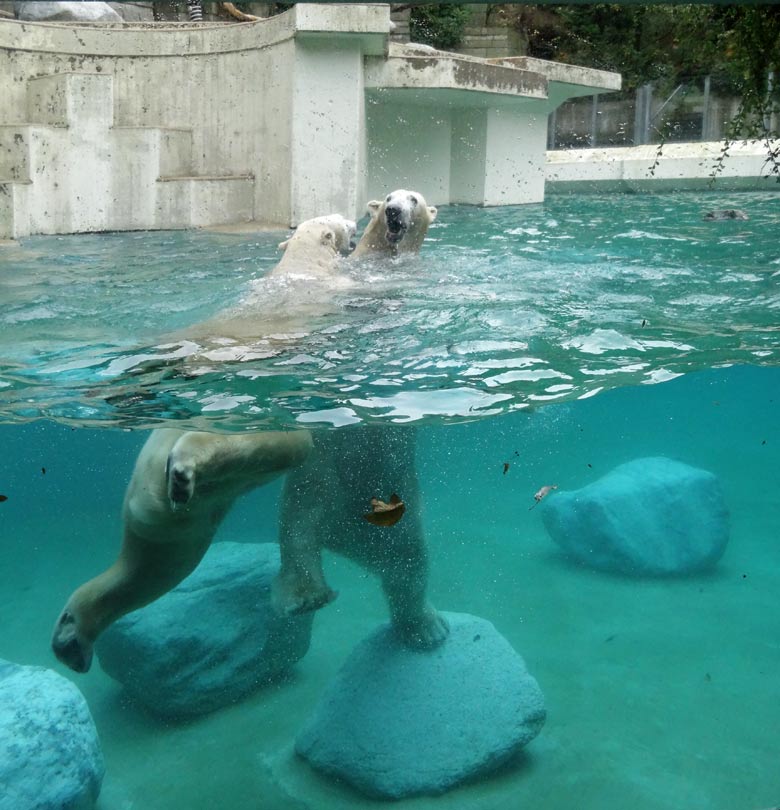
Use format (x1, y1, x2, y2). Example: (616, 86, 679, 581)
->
(0, 192, 780, 430)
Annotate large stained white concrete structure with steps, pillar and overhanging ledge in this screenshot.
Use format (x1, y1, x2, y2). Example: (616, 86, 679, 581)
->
(0, 4, 620, 238)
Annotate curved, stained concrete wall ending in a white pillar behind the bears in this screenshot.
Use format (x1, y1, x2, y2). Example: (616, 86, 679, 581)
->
(0, 6, 389, 236)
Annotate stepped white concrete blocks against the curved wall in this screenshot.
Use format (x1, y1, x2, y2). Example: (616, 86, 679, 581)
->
(0, 72, 255, 238)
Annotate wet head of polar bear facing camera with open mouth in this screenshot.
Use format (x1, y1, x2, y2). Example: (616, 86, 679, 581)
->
(352, 188, 438, 256)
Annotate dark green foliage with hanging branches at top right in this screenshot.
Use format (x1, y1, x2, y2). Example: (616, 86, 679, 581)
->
(511, 3, 780, 174)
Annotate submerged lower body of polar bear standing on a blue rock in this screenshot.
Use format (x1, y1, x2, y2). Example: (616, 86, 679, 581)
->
(272, 425, 449, 649)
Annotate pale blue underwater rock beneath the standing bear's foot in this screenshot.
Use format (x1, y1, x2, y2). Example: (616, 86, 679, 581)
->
(295, 613, 546, 799)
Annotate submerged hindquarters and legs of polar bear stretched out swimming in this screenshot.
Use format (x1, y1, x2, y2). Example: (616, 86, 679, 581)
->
(52, 428, 312, 672)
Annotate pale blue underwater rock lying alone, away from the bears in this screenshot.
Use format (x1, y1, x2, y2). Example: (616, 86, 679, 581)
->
(542, 457, 729, 576)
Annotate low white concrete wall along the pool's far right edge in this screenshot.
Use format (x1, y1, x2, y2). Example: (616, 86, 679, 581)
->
(546, 141, 780, 193)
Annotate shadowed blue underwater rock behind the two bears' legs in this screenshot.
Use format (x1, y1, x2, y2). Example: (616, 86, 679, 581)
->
(95, 542, 313, 717)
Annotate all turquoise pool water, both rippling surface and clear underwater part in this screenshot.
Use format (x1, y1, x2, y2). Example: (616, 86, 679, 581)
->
(0, 194, 780, 810)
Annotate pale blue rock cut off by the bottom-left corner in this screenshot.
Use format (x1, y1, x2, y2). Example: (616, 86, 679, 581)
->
(0, 659, 104, 810)
